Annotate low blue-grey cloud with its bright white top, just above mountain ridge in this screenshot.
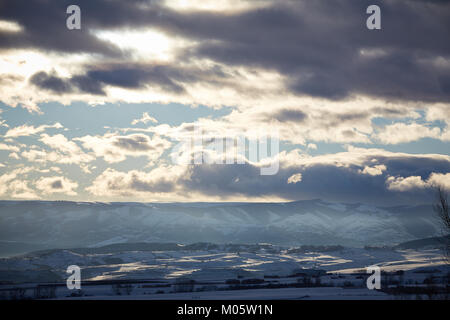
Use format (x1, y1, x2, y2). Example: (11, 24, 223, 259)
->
(180, 149, 450, 204)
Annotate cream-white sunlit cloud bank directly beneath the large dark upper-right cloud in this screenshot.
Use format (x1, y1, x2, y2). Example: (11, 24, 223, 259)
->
(137, 102, 378, 145)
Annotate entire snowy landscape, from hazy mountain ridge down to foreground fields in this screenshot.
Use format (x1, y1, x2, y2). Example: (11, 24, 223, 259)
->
(0, 200, 449, 299)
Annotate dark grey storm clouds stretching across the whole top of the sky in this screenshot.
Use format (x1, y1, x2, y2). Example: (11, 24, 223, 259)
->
(0, 0, 450, 102)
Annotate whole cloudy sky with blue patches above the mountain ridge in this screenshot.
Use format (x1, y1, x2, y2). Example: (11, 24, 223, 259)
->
(0, 0, 450, 206)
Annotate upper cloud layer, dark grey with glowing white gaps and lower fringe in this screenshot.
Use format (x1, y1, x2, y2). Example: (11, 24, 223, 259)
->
(0, 0, 450, 113)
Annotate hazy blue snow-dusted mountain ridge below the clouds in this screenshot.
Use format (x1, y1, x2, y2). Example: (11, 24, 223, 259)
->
(0, 200, 440, 256)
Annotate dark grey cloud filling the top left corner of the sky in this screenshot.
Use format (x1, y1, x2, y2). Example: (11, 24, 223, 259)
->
(0, 0, 156, 56)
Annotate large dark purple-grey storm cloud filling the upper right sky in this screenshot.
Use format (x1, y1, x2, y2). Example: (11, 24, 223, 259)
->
(173, 1, 450, 101)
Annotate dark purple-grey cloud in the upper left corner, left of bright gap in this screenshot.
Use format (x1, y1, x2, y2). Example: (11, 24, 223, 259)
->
(0, 0, 126, 56)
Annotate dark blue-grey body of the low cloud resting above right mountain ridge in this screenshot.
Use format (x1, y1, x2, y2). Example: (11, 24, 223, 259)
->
(179, 155, 450, 205)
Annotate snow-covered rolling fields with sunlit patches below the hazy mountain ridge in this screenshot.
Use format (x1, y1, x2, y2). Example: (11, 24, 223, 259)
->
(0, 243, 450, 299)
